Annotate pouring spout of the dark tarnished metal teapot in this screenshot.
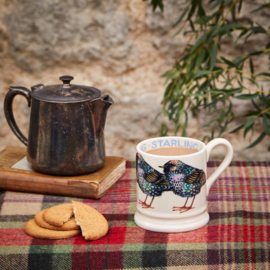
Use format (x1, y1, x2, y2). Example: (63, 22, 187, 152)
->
(90, 95, 114, 138)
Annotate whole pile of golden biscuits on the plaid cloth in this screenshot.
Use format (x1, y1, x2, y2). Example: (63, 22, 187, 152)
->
(24, 201, 108, 240)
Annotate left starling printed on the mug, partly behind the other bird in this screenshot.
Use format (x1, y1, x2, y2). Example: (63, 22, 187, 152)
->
(136, 153, 170, 208)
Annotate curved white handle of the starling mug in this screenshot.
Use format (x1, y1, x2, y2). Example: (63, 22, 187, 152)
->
(206, 138, 233, 196)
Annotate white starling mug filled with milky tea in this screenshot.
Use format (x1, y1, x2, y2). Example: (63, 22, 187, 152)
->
(134, 136, 233, 233)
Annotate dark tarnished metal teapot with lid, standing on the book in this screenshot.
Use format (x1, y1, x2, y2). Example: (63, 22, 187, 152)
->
(4, 75, 114, 175)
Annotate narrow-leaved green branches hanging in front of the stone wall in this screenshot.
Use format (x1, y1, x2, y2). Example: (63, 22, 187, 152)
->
(147, 0, 270, 147)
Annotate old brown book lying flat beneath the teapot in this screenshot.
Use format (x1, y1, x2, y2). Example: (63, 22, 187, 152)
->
(0, 146, 126, 199)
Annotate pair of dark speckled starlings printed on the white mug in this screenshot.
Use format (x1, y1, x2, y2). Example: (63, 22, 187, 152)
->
(136, 154, 206, 213)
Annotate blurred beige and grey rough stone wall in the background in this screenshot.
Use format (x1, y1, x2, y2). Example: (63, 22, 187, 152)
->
(0, 0, 270, 160)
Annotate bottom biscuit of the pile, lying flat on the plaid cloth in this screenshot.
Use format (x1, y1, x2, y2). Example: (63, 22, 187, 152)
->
(24, 219, 81, 239)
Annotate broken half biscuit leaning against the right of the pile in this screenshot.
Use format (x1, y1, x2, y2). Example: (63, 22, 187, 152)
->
(72, 201, 109, 240)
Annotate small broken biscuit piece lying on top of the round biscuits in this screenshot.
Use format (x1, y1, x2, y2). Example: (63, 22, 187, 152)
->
(43, 203, 73, 226)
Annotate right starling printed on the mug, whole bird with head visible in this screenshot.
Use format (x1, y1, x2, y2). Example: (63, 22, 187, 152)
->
(160, 160, 206, 213)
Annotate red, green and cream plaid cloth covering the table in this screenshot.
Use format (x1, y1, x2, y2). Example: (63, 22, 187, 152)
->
(0, 161, 270, 270)
